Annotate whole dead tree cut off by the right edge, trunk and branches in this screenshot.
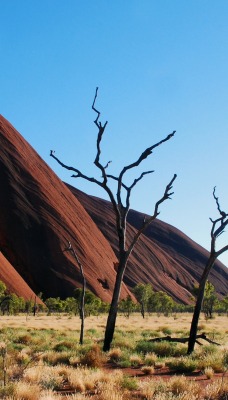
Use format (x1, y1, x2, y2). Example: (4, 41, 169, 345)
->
(188, 187, 228, 354)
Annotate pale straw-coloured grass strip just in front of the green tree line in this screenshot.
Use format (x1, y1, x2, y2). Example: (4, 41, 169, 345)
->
(1, 313, 227, 336)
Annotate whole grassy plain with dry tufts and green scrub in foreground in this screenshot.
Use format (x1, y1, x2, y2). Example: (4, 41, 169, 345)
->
(0, 313, 228, 400)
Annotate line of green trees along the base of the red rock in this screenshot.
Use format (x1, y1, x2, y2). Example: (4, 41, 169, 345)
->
(0, 281, 228, 319)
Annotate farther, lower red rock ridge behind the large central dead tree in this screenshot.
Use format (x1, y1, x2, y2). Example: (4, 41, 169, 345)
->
(68, 185, 228, 304)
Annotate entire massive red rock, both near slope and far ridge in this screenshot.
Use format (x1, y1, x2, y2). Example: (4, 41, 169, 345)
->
(0, 116, 228, 303)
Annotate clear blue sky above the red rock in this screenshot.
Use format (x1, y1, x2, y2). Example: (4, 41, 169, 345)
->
(0, 0, 228, 265)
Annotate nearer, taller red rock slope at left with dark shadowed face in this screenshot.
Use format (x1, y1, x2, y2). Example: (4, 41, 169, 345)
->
(0, 116, 129, 301)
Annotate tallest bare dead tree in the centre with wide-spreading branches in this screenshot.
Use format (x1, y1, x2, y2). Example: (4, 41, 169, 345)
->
(50, 88, 176, 351)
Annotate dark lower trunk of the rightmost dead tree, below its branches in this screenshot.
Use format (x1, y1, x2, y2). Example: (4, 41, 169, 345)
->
(188, 254, 216, 354)
